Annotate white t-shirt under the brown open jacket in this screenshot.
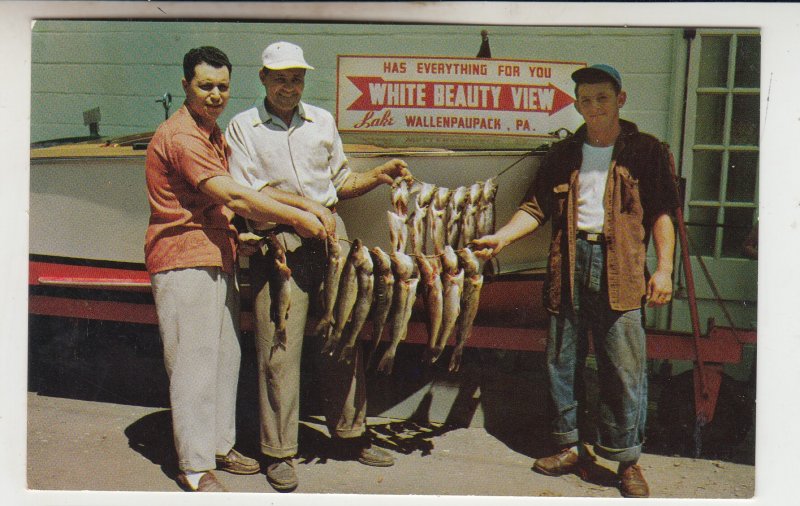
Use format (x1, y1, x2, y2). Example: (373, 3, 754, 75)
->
(578, 144, 614, 233)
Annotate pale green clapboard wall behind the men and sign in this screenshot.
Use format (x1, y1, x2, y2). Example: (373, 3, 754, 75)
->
(31, 20, 685, 148)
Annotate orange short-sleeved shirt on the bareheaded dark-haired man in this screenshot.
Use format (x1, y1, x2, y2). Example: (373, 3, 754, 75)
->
(144, 105, 236, 274)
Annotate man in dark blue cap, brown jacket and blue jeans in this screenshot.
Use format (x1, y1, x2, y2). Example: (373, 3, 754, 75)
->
(475, 64, 679, 497)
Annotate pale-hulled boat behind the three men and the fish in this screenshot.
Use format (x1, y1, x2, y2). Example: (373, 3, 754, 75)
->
(29, 132, 549, 334)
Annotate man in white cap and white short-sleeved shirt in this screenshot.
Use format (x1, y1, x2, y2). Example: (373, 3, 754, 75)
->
(226, 42, 411, 491)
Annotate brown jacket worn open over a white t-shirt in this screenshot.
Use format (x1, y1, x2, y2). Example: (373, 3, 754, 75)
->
(519, 120, 679, 313)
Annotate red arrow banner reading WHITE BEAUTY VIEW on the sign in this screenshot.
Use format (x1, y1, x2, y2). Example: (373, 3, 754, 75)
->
(347, 76, 574, 116)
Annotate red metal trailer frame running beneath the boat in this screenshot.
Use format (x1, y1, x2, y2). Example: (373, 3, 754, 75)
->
(28, 251, 756, 424)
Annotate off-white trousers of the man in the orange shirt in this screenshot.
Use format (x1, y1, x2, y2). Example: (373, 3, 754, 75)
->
(150, 267, 241, 471)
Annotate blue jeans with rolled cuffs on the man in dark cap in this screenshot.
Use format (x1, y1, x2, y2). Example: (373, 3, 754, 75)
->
(546, 239, 647, 462)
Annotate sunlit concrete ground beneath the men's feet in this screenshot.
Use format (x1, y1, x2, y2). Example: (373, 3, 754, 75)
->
(27, 392, 754, 498)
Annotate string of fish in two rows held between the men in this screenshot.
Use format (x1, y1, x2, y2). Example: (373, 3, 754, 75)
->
(284, 150, 528, 374)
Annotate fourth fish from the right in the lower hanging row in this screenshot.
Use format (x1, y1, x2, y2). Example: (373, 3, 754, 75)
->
(378, 252, 419, 374)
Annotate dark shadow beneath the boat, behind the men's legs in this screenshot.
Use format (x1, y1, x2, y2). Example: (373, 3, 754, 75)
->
(28, 316, 755, 472)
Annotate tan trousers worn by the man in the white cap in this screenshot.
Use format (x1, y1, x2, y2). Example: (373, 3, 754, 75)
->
(250, 216, 367, 458)
